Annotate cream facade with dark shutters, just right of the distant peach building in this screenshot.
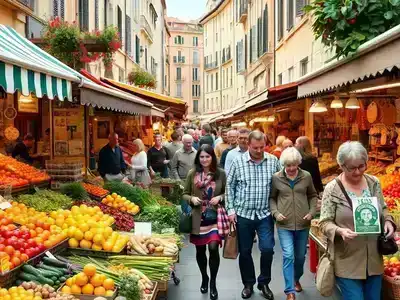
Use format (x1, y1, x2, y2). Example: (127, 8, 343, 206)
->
(201, 0, 274, 114)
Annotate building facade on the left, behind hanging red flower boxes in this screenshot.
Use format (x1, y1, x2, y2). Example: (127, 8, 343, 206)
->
(0, 0, 166, 93)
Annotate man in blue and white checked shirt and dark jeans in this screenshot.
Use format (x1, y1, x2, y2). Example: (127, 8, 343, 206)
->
(225, 131, 281, 300)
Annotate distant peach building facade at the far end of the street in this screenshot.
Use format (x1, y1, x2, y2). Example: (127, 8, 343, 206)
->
(167, 18, 204, 118)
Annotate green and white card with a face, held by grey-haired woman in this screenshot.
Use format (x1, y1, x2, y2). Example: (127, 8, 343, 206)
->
(353, 197, 381, 234)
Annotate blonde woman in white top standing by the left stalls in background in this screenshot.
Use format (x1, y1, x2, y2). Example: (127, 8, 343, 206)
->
(131, 139, 151, 186)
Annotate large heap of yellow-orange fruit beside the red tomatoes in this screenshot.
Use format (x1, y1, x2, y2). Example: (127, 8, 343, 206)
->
(59, 204, 128, 252)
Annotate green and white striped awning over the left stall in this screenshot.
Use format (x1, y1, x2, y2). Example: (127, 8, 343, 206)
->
(0, 25, 80, 101)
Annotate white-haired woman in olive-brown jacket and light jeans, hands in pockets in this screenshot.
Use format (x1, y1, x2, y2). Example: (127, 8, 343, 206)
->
(269, 147, 317, 300)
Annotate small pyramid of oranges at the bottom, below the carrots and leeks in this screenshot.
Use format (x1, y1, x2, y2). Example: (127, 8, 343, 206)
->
(61, 264, 116, 297)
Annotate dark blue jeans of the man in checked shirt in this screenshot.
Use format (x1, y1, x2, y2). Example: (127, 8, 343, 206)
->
(236, 216, 275, 287)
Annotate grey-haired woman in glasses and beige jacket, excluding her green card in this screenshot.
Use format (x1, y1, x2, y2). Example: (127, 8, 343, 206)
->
(320, 142, 396, 300)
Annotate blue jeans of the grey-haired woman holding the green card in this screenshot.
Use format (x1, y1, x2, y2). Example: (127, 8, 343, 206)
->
(336, 275, 382, 300)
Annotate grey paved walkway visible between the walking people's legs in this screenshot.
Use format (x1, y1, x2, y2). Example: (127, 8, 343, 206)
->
(168, 240, 340, 300)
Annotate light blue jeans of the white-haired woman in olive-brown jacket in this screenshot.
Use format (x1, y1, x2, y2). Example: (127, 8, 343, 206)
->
(278, 228, 309, 294)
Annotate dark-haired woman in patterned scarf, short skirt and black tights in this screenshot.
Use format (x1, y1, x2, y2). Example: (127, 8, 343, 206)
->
(183, 144, 229, 300)
